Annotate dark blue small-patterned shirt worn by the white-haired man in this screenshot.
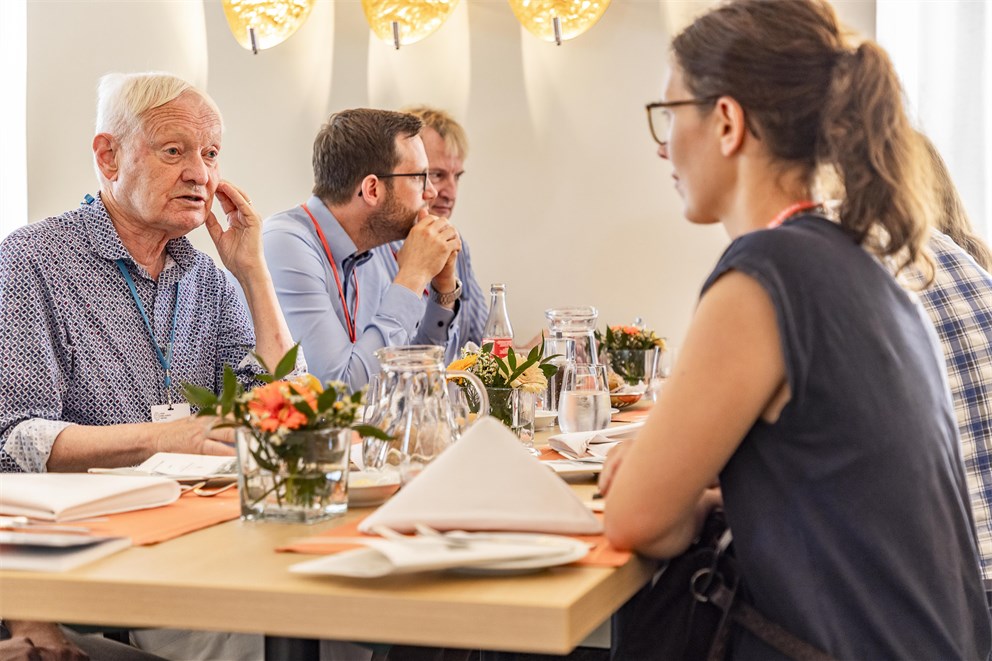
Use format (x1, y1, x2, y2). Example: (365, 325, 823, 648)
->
(0, 197, 262, 472)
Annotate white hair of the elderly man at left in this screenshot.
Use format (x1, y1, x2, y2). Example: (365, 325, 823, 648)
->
(94, 71, 224, 181)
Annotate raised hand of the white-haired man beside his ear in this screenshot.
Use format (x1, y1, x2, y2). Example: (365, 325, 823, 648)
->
(206, 181, 265, 282)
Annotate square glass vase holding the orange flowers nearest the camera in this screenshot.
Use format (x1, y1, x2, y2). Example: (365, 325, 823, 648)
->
(237, 427, 354, 523)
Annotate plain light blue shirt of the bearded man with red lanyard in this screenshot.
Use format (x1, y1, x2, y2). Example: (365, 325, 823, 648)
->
(262, 196, 461, 390)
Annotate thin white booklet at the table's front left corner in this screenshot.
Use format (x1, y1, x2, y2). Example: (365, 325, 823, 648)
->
(0, 530, 131, 572)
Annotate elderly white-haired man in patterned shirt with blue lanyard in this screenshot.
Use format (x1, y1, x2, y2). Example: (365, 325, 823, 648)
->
(0, 73, 302, 658)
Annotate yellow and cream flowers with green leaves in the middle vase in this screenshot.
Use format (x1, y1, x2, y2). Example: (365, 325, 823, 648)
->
(448, 343, 558, 427)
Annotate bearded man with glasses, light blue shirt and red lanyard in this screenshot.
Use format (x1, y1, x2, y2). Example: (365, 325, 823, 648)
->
(263, 108, 462, 389)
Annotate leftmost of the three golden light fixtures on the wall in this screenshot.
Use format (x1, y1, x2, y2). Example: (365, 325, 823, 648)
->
(224, 0, 315, 55)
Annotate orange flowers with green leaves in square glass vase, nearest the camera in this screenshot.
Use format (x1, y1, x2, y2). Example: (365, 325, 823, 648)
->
(183, 345, 389, 520)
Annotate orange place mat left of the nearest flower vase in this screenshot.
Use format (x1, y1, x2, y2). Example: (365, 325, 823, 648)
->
(79, 489, 241, 546)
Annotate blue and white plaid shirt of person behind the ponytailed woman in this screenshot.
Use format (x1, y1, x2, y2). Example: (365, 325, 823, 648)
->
(905, 230, 992, 579)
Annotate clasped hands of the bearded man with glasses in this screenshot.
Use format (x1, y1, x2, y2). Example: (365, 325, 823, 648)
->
(395, 209, 462, 294)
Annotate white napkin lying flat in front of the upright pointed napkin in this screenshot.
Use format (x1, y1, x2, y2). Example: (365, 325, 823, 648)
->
(289, 537, 574, 578)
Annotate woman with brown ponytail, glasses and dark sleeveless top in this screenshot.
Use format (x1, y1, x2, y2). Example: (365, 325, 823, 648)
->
(600, 0, 992, 660)
